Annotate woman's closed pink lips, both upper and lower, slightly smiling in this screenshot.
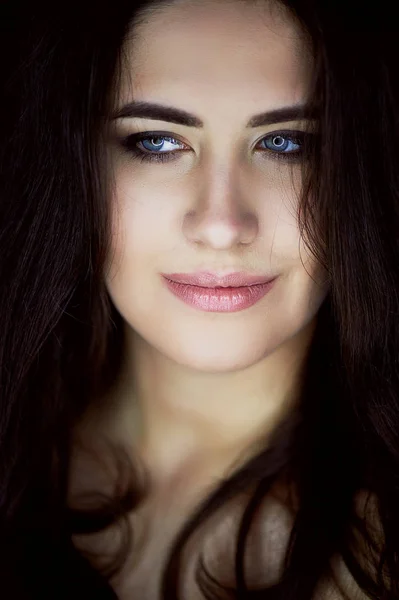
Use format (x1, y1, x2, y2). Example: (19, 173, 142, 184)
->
(163, 271, 277, 312)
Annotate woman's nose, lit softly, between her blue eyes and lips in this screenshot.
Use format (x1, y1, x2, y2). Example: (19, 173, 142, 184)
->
(184, 162, 259, 250)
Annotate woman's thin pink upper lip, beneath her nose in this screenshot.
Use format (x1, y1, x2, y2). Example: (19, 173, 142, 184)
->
(164, 271, 276, 288)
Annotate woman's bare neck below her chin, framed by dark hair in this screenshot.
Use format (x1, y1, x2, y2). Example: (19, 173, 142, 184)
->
(104, 322, 315, 482)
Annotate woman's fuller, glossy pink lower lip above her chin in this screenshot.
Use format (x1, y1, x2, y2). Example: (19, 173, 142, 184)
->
(164, 277, 276, 312)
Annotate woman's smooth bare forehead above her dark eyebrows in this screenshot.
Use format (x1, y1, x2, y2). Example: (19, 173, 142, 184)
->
(120, 0, 312, 112)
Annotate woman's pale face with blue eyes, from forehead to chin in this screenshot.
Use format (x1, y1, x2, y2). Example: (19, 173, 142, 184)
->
(106, 0, 327, 372)
